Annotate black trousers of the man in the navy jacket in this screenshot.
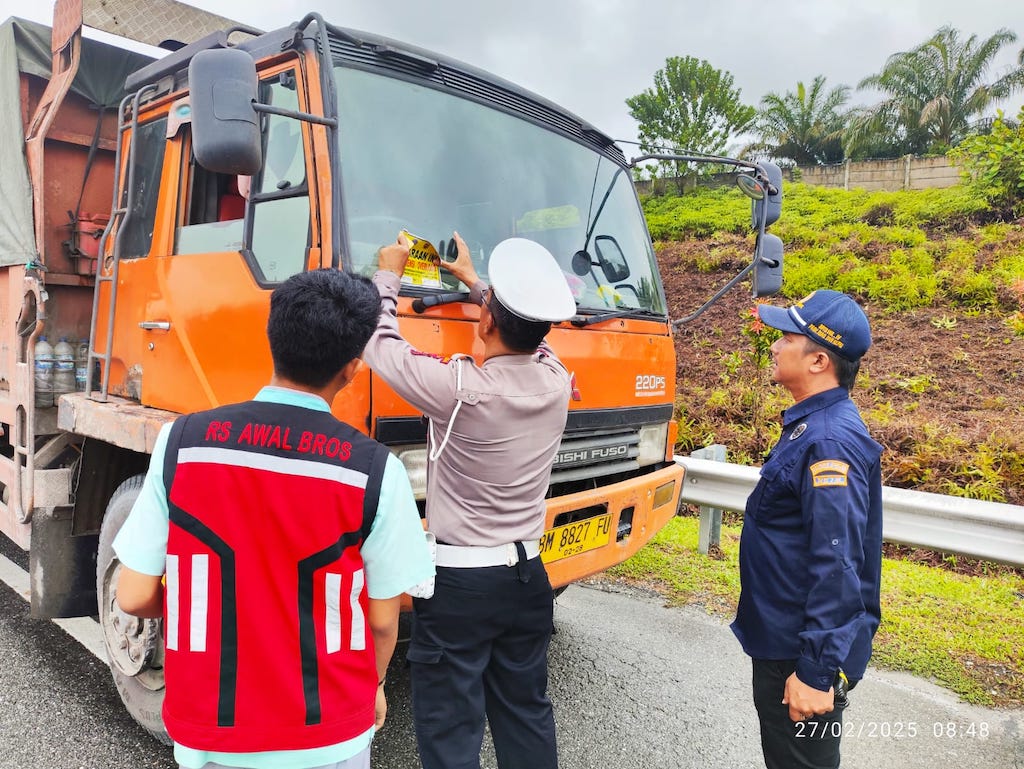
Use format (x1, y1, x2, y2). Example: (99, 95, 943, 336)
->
(753, 659, 843, 769)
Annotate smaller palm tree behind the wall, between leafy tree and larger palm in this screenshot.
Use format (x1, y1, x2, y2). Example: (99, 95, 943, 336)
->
(744, 75, 850, 166)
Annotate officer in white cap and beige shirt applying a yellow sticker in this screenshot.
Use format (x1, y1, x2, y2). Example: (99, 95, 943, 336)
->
(364, 233, 575, 769)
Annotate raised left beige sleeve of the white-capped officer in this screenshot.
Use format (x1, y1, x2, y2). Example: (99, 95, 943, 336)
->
(362, 270, 456, 419)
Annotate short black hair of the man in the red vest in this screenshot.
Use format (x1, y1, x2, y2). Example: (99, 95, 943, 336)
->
(266, 269, 381, 387)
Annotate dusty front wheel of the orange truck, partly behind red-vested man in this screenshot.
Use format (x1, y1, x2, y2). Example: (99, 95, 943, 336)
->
(96, 475, 171, 744)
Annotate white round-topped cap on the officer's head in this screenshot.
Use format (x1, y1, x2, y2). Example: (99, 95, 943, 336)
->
(487, 238, 575, 323)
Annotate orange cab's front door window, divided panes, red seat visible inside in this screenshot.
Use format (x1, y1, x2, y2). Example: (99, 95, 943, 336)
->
(176, 73, 309, 284)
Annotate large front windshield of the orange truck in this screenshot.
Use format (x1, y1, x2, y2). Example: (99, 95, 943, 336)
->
(335, 67, 665, 315)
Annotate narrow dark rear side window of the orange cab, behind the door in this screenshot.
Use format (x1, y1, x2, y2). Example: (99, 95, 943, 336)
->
(118, 118, 167, 259)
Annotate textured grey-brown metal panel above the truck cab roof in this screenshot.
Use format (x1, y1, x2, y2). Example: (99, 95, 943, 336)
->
(84, 0, 258, 46)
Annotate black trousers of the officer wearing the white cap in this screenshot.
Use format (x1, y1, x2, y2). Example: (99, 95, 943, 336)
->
(408, 558, 558, 769)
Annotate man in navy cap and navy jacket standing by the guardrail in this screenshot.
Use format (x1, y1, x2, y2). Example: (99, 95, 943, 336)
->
(732, 291, 882, 769)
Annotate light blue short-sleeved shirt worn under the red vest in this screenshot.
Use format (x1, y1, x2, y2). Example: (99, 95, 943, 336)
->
(114, 387, 434, 769)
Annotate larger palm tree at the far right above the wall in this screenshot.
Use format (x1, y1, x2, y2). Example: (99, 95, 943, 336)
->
(846, 27, 1024, 157)
